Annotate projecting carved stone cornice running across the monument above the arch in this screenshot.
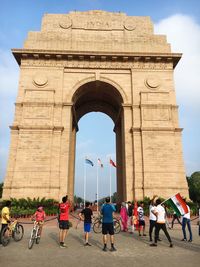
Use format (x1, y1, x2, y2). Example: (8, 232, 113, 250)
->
(12, 49, 182, 69)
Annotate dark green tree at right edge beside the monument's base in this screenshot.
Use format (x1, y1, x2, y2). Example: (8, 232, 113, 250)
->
(187, 172, 200, 204)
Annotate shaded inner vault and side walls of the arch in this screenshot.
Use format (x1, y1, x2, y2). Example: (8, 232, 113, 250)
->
(68, 81, 126, 204)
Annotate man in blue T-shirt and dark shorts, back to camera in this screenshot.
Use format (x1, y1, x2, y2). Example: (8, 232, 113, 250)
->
(101, 197, 116, 251)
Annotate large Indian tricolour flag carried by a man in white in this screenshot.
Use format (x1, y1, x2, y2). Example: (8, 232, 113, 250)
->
(166, 193, 188, 216)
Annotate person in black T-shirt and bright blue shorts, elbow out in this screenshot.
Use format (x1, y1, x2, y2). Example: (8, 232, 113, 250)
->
(79, 202, 93, 246)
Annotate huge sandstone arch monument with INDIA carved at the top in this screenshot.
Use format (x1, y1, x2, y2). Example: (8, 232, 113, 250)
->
(3, 10, 188, 201)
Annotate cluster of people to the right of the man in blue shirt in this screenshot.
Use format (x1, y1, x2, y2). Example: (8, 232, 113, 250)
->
(120, 196, 192, 247)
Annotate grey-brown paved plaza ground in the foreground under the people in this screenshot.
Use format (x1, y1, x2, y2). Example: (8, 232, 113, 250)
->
(0, 216, 200, 267)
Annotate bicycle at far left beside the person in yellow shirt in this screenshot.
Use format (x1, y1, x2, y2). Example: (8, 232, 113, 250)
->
(1, 219, 24, 247)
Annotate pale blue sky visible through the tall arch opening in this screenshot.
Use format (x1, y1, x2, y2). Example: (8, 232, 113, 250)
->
(74, 112, 116, 202)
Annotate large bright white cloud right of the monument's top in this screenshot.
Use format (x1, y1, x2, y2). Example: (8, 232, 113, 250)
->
(155, 14, 200, 108)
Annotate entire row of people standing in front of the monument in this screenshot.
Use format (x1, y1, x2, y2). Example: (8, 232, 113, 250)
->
(0, 196, 192, 251)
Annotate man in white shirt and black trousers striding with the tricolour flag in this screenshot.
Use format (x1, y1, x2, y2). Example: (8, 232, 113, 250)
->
(150, 198, 173, 248)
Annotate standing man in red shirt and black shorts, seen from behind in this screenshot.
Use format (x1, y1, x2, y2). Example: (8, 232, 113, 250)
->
(59, 196, 71, 248)
